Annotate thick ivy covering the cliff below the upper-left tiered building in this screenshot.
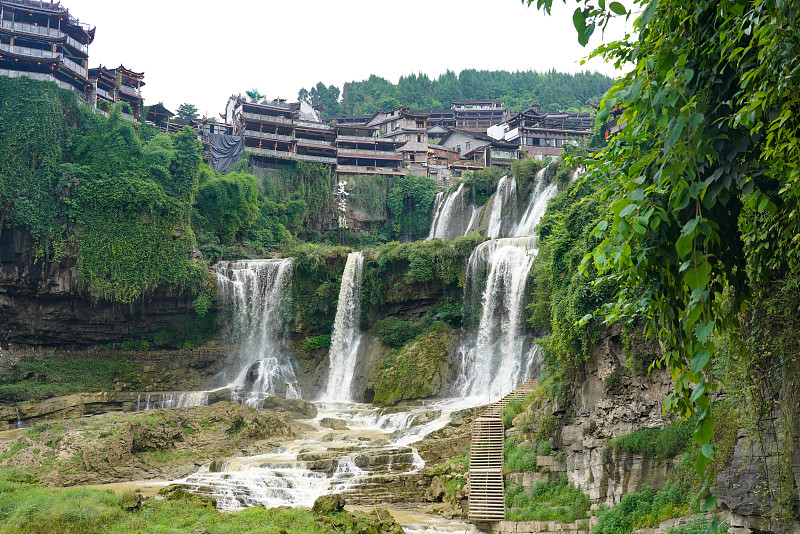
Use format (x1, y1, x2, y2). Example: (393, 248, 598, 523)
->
(0, 78, 210, 303)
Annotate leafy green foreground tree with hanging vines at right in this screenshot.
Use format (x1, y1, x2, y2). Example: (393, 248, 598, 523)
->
(529, 0, 800, 506)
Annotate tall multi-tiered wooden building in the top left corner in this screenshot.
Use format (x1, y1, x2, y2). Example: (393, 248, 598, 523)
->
(0, 0, 95, 97)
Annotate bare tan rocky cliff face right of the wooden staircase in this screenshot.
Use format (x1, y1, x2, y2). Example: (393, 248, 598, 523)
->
(507, 330, 673, 506)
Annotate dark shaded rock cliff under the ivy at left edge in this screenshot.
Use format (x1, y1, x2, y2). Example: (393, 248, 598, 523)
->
(0, 228, 198, 349)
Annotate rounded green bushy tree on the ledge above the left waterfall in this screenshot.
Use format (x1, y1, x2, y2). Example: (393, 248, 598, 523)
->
(194, 171, 263, 245)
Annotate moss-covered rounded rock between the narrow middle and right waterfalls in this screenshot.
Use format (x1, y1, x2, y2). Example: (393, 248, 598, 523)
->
(374, 326, 453, 406)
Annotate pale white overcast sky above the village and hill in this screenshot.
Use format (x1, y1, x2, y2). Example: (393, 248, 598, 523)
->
(61, 0, 621, 116)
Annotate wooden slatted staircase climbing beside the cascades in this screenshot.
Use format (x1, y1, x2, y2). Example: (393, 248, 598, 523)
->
(468, 380, 537, 521)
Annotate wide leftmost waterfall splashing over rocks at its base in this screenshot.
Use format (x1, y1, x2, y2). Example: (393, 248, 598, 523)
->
(215, 259, 300, 408)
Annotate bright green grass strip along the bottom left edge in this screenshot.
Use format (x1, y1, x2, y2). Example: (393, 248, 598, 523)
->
(0, 469, 388, 534)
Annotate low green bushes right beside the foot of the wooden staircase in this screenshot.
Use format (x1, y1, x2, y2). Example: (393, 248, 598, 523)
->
(506, 476, 591, 523)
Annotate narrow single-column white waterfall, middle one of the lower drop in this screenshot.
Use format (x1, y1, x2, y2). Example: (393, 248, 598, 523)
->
(322, 252, 364, 401)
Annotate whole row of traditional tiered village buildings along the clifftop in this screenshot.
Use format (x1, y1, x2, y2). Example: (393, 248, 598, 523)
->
(0, 0, 594, 188)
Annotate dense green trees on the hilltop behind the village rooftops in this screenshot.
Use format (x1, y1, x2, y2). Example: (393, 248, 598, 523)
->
(332, 69, 611, 115)
